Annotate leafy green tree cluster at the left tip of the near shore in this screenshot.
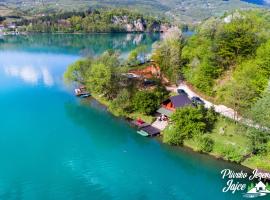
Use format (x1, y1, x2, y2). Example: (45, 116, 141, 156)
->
(64, 51, 121, 99)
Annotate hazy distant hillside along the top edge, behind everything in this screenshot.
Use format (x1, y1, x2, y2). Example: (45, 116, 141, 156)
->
(0, 0, 262, 23)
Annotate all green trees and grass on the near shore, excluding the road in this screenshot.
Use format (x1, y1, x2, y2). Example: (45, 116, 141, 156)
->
(65, 10, 270, 171)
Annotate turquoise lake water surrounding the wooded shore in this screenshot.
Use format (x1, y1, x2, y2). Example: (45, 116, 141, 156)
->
(0, 34, 267, 200)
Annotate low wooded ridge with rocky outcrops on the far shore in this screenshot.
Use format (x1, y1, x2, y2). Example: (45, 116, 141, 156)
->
(17, 9, 169, 33)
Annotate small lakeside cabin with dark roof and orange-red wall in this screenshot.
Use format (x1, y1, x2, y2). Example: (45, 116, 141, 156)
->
(157, 94, 192, 117)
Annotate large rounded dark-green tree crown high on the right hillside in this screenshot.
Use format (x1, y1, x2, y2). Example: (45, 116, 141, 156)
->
(213, 17, 261, 69)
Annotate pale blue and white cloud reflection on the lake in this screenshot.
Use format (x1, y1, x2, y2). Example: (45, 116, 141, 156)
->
(0, 51, 79, 87)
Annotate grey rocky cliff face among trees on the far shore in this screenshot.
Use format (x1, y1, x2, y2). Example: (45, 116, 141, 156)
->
(112, 16, 170, 32)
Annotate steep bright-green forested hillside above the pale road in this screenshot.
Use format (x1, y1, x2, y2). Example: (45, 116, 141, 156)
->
(182, 10, 270, 113)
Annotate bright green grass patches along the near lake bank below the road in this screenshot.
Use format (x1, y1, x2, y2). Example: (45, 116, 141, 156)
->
(85, 94, 270, 171)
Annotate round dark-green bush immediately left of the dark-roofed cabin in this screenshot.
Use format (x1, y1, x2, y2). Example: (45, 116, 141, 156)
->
(133, 91, 160, 114)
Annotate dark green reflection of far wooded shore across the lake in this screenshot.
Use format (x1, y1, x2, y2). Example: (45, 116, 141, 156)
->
(0, 33, 160, 55)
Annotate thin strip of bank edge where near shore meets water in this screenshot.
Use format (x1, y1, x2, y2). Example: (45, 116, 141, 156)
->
(86, 95, 268, 172)
